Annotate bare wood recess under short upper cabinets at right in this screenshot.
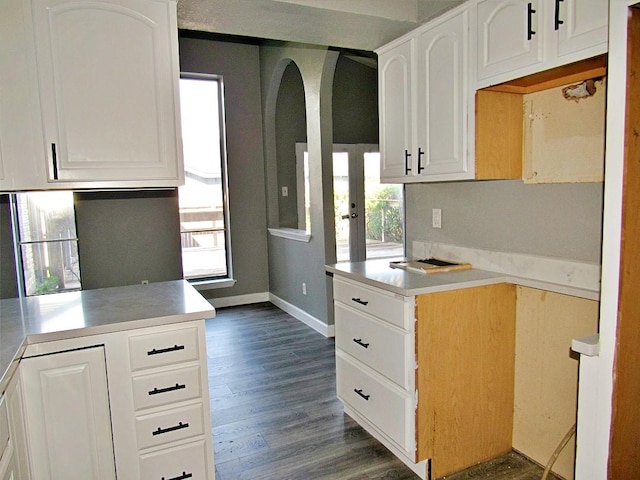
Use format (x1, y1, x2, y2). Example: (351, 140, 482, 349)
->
(476, 56, 606, 183)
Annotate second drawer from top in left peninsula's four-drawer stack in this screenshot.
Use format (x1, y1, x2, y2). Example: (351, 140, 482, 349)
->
(132, 365, 202, 410)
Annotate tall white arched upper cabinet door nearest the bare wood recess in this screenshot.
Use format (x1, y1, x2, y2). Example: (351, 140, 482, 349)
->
(417, 10, 469, 176)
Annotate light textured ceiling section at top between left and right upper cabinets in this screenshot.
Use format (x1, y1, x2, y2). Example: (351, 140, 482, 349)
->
(178, 0, 463, 51)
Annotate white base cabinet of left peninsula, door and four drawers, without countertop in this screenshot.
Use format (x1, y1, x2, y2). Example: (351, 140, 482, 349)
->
(13, 321, 214, 480)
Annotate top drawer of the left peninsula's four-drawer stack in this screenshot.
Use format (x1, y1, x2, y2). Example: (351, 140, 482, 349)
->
(129, 327, 198, 371)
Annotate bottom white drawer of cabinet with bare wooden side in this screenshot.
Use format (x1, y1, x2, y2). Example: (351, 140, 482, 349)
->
(336, 352, 415, 452)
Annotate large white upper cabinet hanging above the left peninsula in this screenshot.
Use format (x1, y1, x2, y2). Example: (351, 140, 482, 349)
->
(0, 0, 184, 190)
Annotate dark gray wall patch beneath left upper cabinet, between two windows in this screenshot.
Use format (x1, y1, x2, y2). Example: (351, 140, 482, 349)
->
(74, 189, 182, 290)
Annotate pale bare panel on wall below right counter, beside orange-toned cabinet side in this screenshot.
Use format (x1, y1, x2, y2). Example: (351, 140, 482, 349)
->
(513, 287, 599, 480)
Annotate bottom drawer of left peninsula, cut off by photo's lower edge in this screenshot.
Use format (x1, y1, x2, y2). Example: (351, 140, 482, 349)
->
(140, 440, 213, 480)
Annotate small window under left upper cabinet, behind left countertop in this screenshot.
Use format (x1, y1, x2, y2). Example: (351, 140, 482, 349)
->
(10, 191, 81, 296)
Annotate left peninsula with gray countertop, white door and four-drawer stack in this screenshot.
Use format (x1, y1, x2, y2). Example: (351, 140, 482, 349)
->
(0, 280, 215, 479)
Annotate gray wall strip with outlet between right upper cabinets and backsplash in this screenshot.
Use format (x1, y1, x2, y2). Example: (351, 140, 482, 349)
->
(406, 180, 603, 263)
